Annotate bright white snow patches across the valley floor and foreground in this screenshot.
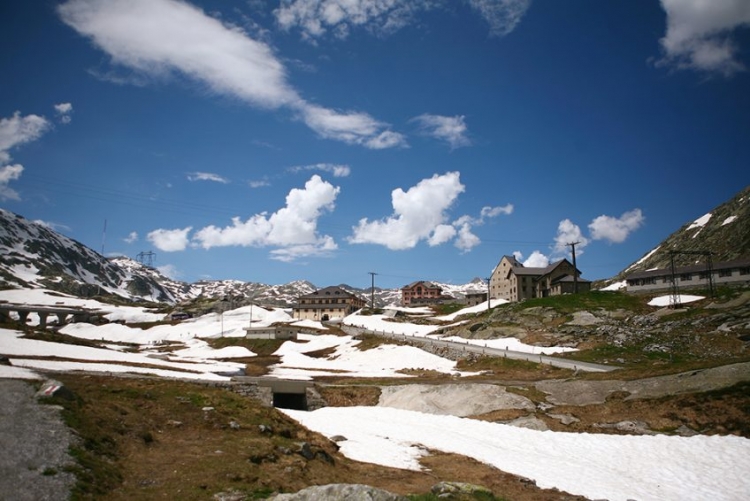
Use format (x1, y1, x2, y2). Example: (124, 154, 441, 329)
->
(0, 290, 750, 501)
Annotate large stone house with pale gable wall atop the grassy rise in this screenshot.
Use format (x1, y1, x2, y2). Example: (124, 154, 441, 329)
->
(490, 256, 591, 301)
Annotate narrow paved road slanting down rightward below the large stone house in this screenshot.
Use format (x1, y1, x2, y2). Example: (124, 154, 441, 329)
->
(342, 325, 619, 372)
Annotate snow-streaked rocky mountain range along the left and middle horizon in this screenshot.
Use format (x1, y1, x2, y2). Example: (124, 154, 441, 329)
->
(0, 209, 484, 306)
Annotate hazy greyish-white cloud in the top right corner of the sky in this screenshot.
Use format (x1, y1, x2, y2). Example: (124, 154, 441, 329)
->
(657, 0, 750, 76)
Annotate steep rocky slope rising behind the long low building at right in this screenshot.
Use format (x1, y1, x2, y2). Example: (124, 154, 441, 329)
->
(617, 186, 750, 278)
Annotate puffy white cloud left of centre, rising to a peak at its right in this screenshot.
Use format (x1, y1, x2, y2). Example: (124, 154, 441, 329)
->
(193, 175, 340, 260)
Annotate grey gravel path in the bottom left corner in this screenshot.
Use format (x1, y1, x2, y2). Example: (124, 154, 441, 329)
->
(0, 379, 75, 501)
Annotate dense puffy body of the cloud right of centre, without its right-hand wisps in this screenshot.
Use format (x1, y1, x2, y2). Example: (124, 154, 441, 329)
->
(349, 172, 464, 250)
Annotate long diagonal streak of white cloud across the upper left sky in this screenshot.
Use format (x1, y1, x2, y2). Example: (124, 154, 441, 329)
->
(58, 0, 404, 149)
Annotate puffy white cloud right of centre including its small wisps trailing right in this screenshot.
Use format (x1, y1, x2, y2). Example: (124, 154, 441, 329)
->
(348, 172, 512, 252)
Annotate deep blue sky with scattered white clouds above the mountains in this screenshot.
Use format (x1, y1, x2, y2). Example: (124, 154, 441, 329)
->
(0, 0, 750, 287)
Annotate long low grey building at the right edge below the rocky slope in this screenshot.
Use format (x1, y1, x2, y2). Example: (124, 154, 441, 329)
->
(625, 259, 750, 292)
